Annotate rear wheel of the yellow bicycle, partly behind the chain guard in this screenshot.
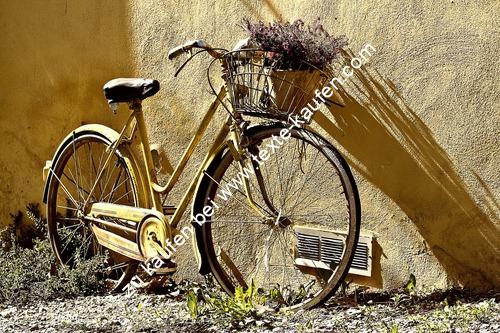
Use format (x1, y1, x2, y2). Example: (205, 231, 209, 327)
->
(47, 131, 139, 291)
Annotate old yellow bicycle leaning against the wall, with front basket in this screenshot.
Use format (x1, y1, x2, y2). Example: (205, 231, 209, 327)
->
(43, 40, 360, 309)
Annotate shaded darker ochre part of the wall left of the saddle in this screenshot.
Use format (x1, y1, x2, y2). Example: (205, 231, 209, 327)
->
(0, 1, 132, 225)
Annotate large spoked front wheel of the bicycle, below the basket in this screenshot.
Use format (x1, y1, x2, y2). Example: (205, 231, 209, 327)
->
(195, 126, 360, 309)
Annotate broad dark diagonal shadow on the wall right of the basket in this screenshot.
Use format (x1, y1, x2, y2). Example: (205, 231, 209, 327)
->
(317, 56, 500, 289)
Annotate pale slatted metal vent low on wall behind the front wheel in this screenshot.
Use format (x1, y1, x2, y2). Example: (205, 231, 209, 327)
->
(295, 227, 372, 276)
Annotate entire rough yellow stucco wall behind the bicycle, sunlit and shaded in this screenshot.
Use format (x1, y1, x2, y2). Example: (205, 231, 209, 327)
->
(0, 0, 500, 288)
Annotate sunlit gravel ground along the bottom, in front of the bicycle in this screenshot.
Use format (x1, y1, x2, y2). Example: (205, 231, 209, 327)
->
(0, 293, 500, 333)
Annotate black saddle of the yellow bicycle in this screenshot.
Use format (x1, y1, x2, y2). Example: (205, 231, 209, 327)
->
(103, 78, 160, 103)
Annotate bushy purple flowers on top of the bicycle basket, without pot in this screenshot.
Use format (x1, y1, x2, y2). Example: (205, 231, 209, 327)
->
(241, 17, 347, 70)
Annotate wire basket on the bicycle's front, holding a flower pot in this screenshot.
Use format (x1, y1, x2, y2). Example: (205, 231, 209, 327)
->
(225, 50, 326, 122)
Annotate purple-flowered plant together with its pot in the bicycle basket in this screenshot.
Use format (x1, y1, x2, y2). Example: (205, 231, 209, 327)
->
(242, 18, 347, 114)
